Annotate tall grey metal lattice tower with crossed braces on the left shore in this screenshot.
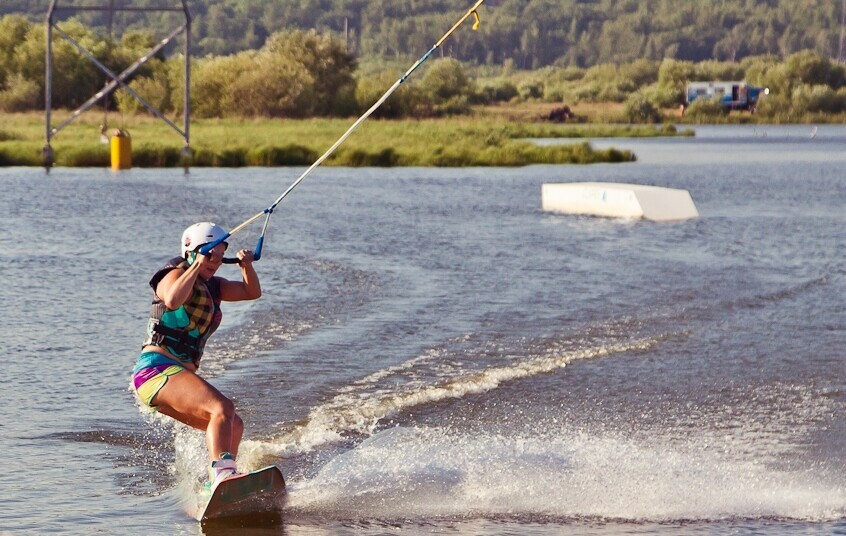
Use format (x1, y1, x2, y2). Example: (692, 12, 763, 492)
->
(42, 0, 192, 168)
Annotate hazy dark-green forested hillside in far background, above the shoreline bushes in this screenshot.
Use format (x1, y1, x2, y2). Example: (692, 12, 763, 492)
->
(0, 0, 844, 70)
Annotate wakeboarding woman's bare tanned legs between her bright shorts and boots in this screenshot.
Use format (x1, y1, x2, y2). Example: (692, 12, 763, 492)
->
(152, 370, 244, 460)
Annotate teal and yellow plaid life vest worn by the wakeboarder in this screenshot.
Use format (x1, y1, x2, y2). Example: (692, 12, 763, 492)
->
(144, 257, 223, 364)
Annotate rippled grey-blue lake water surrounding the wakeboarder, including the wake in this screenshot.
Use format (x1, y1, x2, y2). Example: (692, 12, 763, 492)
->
(0, 126, 846, 535)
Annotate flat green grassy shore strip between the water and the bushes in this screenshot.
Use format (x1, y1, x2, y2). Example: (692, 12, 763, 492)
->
(0, 108, 677, 167)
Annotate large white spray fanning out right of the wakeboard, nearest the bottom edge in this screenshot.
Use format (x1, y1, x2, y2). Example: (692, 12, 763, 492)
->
(288, 428, 846, 522)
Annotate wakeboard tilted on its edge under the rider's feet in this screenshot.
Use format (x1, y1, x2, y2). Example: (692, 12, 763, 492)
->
(197, 465, 285, 521)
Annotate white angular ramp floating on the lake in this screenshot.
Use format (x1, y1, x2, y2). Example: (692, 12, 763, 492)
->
(541, 182, 699, 221)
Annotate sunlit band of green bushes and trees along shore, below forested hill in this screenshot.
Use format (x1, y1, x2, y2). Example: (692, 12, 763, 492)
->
(0, 11, 846, 122)
